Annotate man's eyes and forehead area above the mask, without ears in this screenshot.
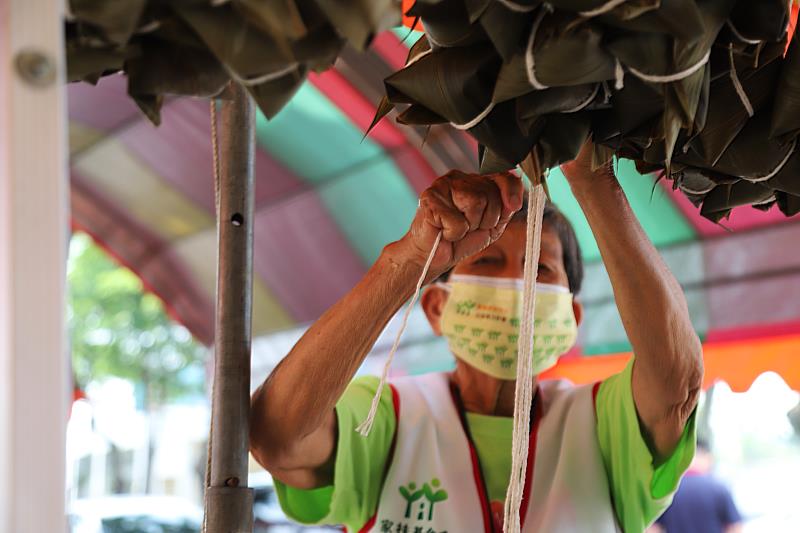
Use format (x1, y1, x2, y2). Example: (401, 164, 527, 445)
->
(453, 222, 569, 288)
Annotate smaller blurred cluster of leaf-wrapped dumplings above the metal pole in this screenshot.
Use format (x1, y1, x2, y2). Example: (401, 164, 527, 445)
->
(66, 0, 400, 124)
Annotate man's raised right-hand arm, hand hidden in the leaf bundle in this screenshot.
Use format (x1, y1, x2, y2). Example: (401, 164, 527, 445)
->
(561, 142, 703, 460)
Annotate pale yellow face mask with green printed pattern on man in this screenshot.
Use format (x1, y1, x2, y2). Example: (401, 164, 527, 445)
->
(439, 274, 578, 380)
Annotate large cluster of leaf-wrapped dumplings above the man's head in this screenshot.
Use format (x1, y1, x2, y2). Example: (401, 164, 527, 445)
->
(376, 0, 800, 221)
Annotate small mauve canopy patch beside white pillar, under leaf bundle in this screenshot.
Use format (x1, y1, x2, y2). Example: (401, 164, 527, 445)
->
(67, 74, 142, 131)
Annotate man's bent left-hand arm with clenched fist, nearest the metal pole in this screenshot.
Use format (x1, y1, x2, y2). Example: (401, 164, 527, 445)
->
(250, 171, 523, 488)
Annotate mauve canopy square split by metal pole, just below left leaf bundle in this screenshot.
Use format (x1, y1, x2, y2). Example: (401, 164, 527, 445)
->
(118, 98, 303, 213)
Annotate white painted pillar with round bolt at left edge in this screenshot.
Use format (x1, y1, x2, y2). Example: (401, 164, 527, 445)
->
(0, 0, 69, 533)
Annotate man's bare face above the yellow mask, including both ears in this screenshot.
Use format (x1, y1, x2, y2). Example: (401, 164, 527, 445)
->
(422, 222, 583, 335)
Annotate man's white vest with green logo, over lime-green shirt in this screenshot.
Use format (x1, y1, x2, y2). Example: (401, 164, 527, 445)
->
(362, 374, 620, 533)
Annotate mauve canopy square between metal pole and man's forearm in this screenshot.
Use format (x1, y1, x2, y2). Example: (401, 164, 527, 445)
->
(254, 191, 366, 322)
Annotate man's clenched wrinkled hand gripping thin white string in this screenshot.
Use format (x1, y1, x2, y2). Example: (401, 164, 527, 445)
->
(396, 170, 524, 281)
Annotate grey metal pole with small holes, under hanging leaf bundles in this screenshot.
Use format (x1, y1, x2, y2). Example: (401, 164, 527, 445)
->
(206, 84, 255, 533)
